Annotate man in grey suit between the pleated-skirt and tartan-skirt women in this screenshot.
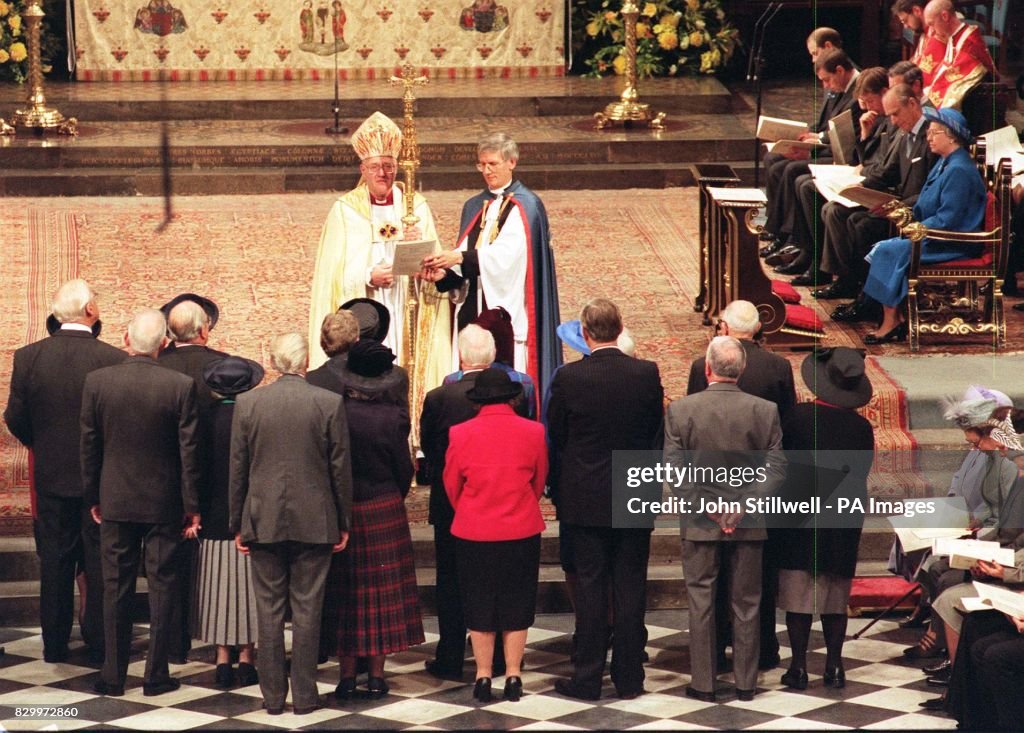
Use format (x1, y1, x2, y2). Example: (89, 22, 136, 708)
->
(228, 333, 352, 715)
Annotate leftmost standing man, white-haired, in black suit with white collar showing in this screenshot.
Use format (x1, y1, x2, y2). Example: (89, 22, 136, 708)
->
(3, 279, 128, 662)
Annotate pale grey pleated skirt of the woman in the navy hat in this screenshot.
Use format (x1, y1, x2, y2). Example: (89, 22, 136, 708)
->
(190, 540, 257, 646)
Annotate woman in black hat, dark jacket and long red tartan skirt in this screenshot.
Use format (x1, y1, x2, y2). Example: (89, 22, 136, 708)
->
(328, 339, 424, 700)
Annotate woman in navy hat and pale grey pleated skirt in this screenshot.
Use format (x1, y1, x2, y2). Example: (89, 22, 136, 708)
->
(190, 356, 263, 688)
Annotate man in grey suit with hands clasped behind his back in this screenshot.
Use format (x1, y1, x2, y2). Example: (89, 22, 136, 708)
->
(664, 336, 785, 702)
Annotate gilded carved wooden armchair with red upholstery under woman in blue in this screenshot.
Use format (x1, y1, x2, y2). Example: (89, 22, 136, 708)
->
(893, 159, 1013, 351)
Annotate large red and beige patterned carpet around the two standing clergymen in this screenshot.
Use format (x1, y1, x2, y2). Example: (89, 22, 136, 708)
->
(0, 188, 942, 533)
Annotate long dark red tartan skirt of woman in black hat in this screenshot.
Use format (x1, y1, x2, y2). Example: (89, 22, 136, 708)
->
(328, 493, 425, 656)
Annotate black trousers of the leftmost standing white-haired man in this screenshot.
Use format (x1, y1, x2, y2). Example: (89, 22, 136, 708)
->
(33, 493, 103, 654)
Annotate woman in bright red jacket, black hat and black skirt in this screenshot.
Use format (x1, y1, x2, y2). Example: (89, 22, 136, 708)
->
(444, 368, 548, 702)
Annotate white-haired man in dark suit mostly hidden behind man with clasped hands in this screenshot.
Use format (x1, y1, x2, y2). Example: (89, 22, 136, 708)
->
(686, 300, 797, 670)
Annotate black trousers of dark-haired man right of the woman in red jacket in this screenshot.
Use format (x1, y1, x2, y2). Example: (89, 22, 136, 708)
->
(572, 524, 650, 695)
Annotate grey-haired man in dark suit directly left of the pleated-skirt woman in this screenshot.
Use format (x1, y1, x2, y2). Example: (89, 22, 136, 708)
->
(81, 308, 200, 696)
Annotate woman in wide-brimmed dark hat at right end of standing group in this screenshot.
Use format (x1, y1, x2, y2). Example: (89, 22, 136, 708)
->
(770, 347, 874, 690)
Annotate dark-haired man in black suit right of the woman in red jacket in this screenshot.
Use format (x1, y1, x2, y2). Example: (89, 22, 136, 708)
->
(547, 298, 665, 700)
